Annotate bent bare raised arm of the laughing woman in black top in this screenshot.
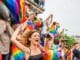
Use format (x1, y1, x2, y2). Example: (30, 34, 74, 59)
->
(11, 26, 29, 53)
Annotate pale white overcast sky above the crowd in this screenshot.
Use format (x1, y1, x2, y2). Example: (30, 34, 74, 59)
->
(39, 0, 80, 35)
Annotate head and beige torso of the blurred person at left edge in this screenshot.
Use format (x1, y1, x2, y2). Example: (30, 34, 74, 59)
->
(0, 20, 10, 54)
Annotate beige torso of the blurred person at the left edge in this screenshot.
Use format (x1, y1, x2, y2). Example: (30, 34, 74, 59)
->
(0, 33, 10, 54)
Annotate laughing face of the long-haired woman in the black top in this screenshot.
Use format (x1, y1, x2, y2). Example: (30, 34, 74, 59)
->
(30, 32, 40, 45)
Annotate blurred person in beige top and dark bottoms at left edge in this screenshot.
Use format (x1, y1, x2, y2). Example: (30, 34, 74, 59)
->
(0, 20, 12, 60)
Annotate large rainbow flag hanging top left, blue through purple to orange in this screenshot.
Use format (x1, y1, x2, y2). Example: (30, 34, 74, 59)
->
(1, 0, 26, 23)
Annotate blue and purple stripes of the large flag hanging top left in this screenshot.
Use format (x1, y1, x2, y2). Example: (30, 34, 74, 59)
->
(2, 0, 20, 23)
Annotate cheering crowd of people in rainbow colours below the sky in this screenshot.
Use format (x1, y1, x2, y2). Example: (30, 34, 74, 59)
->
(0, 0, 80, 60)
